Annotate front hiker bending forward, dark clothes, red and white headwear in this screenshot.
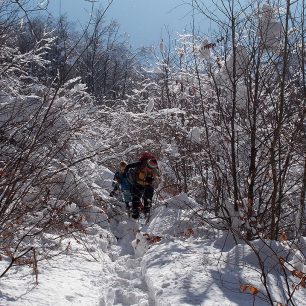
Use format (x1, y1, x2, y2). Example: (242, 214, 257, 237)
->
(124, 152, 159, 219)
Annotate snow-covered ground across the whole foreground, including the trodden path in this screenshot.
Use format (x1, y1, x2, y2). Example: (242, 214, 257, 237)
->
(0, 195, 306, 306)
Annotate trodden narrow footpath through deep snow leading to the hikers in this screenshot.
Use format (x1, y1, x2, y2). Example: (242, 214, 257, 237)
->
(99, 215, 154, 306)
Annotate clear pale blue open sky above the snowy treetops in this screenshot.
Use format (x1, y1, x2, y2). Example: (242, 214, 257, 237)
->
(49, 0, 208, 48)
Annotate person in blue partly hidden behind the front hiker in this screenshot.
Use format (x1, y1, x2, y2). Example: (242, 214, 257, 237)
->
(109, 161, 132, 210)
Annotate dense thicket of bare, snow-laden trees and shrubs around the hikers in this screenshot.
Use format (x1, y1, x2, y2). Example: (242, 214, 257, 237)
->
(0, 1, 306, 302)
